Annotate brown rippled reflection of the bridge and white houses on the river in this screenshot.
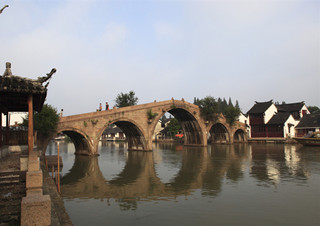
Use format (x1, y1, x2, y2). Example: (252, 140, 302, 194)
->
(61, 145, 308, 206)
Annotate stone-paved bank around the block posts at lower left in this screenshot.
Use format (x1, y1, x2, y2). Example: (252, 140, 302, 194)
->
(0, 147, 73, 226)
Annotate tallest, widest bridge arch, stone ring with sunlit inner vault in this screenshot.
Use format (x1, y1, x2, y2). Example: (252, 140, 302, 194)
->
(149, 104, 207, 146)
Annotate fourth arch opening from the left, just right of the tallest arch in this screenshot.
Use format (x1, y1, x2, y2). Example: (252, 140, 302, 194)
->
(208, 123, 230, 144)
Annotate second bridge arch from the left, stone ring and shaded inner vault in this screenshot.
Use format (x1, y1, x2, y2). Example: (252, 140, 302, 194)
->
(98, 118, 148, 150)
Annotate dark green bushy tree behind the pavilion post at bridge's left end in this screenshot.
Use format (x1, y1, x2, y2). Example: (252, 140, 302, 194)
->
(22, 104, 59, 137)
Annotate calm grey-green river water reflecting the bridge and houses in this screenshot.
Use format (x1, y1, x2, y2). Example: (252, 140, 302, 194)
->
(47, 142, 320, 226)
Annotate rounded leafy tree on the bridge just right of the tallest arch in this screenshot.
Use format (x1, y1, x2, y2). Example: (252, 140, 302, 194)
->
(197, 96, 218, 121)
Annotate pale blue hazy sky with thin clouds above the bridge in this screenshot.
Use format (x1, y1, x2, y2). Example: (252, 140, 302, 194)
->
(0, 0, 320, 115)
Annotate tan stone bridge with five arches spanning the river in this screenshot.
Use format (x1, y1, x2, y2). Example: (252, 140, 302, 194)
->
(53, 99, 246, 155)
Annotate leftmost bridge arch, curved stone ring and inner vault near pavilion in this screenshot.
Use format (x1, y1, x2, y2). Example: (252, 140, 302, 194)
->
(57, 127, 92, 155)
